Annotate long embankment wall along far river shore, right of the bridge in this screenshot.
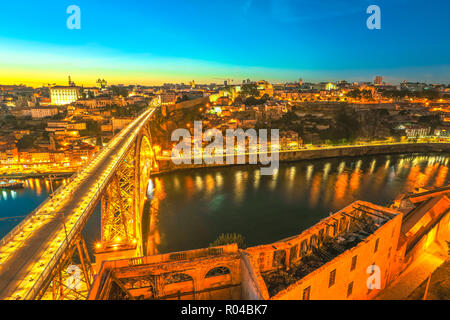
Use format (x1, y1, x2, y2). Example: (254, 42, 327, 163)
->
(153, 143, 450, 175)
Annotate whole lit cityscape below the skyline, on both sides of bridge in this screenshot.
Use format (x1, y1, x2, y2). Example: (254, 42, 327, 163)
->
(0, 76, 450, 175)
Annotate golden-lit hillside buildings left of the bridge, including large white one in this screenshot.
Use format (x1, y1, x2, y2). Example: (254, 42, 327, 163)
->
(0, 81, 148, 175)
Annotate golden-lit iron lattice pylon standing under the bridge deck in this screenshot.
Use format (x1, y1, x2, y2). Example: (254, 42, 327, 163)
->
(96, 126, 156, 262)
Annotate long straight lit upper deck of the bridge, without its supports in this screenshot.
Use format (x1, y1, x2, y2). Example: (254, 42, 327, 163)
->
(0, 108, 155, 299)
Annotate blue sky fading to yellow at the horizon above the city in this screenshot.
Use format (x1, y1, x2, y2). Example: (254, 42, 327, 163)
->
(0, 0, 450, 85)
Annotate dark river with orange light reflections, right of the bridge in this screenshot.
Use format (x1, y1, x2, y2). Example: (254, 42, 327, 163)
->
(143, 154, 449, 254)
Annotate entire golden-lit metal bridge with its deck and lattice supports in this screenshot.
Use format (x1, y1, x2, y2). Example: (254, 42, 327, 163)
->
(0, 107, 156, 300)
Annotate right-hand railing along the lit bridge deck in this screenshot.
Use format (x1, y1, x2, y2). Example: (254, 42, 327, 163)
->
(23, 108, 156, 299)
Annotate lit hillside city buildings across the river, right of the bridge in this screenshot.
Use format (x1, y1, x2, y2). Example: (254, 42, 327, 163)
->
(151, 76, 450, 153)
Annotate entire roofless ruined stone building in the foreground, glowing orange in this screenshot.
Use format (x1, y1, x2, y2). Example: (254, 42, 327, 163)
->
(89, 186, 450, 300)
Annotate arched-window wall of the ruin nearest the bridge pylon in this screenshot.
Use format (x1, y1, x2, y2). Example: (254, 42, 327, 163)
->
(89, 244, 241, 300)
